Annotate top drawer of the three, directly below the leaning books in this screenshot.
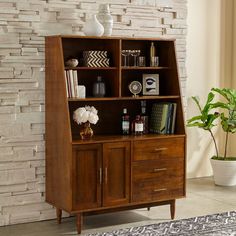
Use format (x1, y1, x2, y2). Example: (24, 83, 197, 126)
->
(133, 138, 184, 161)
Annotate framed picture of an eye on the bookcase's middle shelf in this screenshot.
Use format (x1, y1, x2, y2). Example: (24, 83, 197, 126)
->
(143, 74, 159, 95)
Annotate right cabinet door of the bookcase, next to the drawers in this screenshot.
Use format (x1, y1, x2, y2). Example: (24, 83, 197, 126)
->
(103, 142, 130, 206)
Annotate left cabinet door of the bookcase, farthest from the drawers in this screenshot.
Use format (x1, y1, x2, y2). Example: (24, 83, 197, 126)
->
(72, 144, 102, 210)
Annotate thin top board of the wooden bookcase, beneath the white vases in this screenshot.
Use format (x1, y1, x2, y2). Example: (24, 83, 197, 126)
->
(46, 35, 175, 41)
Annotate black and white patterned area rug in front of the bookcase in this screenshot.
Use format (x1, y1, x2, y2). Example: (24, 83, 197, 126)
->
(88, 211, 236, 236)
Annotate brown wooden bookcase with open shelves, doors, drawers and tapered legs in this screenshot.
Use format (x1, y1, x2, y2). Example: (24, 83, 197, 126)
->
(46, 36, 186, 233)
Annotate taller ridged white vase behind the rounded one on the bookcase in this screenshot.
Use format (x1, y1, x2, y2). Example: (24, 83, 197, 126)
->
(97, 4, 113, 36)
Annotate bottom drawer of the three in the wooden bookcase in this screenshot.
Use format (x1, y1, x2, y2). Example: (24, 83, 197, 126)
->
(132, 177, 184, 202)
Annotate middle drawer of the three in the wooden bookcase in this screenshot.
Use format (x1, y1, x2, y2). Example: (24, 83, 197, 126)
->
(132, 158, 184, 181)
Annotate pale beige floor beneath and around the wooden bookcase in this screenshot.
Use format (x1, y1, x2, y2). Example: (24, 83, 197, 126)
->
(0, 178, 236, 236)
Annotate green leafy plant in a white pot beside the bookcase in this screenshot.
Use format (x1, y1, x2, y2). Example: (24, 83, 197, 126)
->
(187, 88, 236, 186)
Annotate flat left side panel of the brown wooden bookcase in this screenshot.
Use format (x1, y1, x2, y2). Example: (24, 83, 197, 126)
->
(45, 37, 72, 211)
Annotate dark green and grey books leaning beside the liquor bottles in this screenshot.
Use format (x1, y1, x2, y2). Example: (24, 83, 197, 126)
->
(150, 102, 177, 134)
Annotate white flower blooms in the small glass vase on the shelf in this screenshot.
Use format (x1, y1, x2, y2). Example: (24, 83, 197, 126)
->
(73, 106, 99, 125)
